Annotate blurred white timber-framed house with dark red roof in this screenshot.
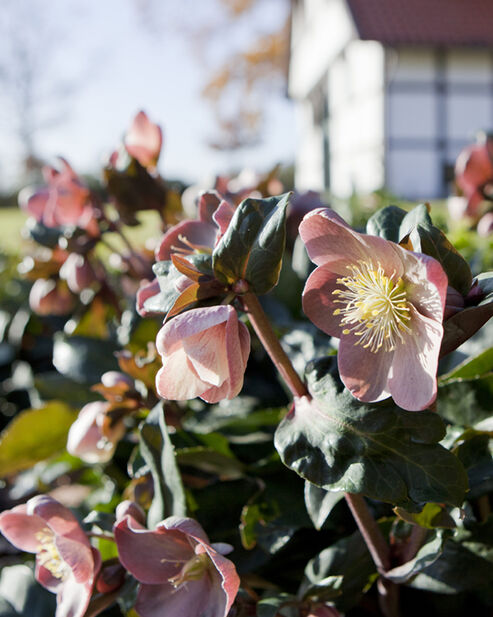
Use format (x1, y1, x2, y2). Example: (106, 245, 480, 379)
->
(288, 0, 493, 200)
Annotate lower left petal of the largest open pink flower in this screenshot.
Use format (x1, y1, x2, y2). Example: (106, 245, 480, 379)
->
(337, 334, 394, 403)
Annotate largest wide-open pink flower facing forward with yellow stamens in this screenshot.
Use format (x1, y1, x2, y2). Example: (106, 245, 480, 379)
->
(300, 208, 448, 411)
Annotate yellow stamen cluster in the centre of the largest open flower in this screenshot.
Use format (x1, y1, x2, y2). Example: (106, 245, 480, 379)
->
(332, 261, 411, 353)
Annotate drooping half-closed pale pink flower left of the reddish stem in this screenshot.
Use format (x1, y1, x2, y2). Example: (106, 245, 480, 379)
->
(156, 305, 250, 403)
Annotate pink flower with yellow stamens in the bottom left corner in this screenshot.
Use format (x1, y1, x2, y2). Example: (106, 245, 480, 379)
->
(0, 495, 101, 617)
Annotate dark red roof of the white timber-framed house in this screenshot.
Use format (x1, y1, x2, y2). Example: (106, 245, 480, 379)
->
(347, 0, 493, 47)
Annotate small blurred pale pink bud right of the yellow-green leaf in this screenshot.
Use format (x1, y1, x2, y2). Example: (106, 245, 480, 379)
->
(67, 401, 125, 464)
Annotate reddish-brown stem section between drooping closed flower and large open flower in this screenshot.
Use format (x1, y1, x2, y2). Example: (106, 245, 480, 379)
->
(241, 291, 309, 397)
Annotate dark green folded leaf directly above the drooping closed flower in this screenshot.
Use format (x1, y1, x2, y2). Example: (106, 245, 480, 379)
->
(212, 193, 290, 294)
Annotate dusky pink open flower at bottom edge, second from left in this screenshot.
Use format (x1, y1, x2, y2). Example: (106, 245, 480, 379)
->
(114, 515, 239, 617)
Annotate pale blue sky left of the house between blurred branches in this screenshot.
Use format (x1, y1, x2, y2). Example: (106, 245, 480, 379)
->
(0, 0, 296, 184)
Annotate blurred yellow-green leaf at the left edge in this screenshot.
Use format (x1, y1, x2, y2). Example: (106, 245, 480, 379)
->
(0, 401, 77, 477)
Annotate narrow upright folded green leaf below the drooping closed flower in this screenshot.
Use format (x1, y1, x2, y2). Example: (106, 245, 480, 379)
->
(139, 403, 186, 528)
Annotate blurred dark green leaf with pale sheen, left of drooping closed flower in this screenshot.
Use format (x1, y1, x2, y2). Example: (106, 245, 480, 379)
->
(53, 333, 118, 385)
